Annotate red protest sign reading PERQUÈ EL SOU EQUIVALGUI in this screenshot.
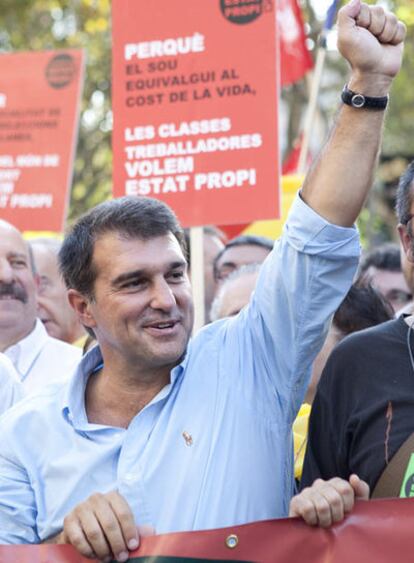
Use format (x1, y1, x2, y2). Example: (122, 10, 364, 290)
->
(112, 0, 279, 226)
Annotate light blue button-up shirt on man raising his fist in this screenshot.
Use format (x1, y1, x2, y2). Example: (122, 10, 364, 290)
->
(0, 194, 359, 543)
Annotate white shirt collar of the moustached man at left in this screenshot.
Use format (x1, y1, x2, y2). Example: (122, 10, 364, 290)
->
(4, 319, 49, 380)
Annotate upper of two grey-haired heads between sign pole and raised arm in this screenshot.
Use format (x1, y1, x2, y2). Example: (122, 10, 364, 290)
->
(213, 235, 274, 285)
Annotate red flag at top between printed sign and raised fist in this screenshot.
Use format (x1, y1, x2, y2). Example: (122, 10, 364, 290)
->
(277, 0, 313, 86)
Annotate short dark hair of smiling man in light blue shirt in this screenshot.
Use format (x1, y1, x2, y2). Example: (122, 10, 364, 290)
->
(59, 196, 186, 297)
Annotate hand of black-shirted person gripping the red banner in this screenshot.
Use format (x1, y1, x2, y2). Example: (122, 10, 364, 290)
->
(289, 475, 369, 528)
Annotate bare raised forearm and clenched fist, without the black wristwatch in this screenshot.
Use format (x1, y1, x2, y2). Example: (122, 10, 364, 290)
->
(302, 0, 406, 227)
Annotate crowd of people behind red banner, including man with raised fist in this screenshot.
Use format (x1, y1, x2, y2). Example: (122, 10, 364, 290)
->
(0, 0, 414, 561)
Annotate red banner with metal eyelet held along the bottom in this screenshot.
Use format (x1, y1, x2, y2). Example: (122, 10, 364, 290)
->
(0, 499, 414, 563)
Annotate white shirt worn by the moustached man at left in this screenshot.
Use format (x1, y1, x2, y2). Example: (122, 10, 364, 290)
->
(4, 319, 82, 393)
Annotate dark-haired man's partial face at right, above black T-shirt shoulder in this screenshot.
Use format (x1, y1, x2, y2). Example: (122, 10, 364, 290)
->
(359, 244, 412, 313)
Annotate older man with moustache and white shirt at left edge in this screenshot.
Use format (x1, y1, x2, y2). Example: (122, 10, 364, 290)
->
(0, 220, 81, 392)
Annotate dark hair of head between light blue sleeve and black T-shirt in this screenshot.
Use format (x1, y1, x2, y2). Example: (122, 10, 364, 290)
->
(333, 282, 394, 336)
